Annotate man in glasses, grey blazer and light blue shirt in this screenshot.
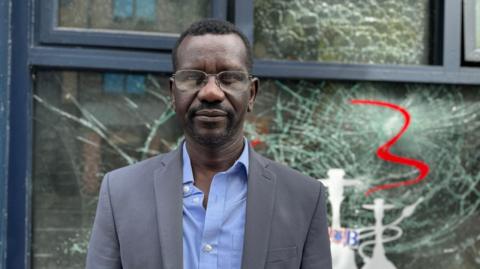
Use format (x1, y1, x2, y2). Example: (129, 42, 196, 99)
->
(87, 20, 331, 269)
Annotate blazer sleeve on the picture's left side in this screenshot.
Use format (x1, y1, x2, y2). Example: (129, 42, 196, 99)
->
(86, 174, 122, 269)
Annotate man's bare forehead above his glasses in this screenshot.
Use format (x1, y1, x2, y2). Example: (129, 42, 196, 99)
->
(177, 34, 247, 71)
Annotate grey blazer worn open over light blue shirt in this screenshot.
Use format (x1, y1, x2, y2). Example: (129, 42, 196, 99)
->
(87, 144, 332, 269)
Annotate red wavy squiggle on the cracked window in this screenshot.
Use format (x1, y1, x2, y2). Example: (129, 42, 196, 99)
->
(351, 100, 430, 196)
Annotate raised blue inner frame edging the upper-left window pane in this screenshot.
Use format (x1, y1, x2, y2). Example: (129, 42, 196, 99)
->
(37, 0, 227, 50)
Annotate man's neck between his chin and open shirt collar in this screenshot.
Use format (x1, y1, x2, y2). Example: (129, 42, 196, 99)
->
(185, 135, 244, 173)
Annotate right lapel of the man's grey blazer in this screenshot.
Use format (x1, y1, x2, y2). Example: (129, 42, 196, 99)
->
(242, 147, 276, 269)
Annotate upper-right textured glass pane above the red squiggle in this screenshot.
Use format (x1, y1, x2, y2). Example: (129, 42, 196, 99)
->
(254, 0, 431, 64)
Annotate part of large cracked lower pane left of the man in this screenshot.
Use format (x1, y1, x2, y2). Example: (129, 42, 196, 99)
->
(33, 71, 181, 269)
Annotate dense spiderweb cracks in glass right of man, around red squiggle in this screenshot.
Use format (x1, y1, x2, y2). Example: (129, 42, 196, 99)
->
(246, 81, 480, 268)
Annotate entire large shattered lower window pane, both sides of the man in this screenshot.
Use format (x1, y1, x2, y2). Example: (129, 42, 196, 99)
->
(33, 71, 480, 269)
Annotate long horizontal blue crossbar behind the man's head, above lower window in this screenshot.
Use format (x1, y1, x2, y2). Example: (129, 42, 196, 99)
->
(29, 47, 480, 84)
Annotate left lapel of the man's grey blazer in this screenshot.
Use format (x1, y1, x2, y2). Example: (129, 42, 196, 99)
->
(154, 147, 183, 269)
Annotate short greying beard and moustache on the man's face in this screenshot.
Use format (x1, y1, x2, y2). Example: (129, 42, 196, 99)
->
(185, 103, 238, 146)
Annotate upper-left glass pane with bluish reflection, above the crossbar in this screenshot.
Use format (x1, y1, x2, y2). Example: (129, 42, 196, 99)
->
(58, 0, 211, 33)
